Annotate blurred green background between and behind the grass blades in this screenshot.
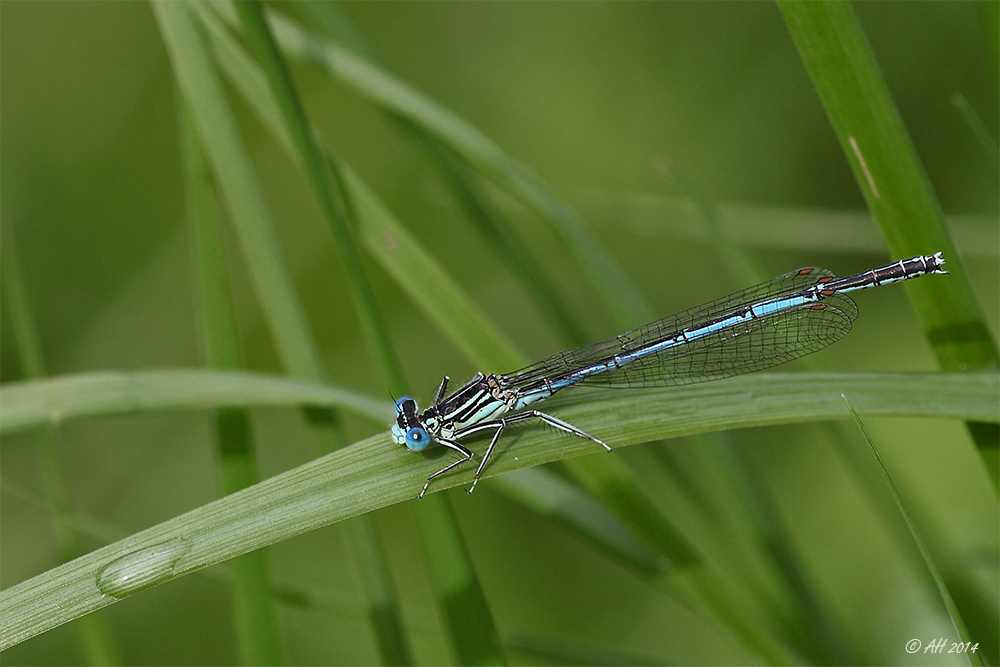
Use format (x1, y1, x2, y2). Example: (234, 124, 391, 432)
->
(0, 0, 1000, 665)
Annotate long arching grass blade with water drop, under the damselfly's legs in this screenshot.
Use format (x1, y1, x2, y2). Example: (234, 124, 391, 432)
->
(0, 373, 1000, 650)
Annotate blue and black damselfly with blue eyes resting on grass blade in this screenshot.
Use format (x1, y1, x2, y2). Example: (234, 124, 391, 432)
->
(392, 253, 948, 497)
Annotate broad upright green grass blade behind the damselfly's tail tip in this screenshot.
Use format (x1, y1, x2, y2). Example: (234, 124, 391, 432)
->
(778, 0, 998, 370)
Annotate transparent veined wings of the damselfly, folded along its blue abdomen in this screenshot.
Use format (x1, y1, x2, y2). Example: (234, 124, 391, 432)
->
(507, 268, 858, 387)
